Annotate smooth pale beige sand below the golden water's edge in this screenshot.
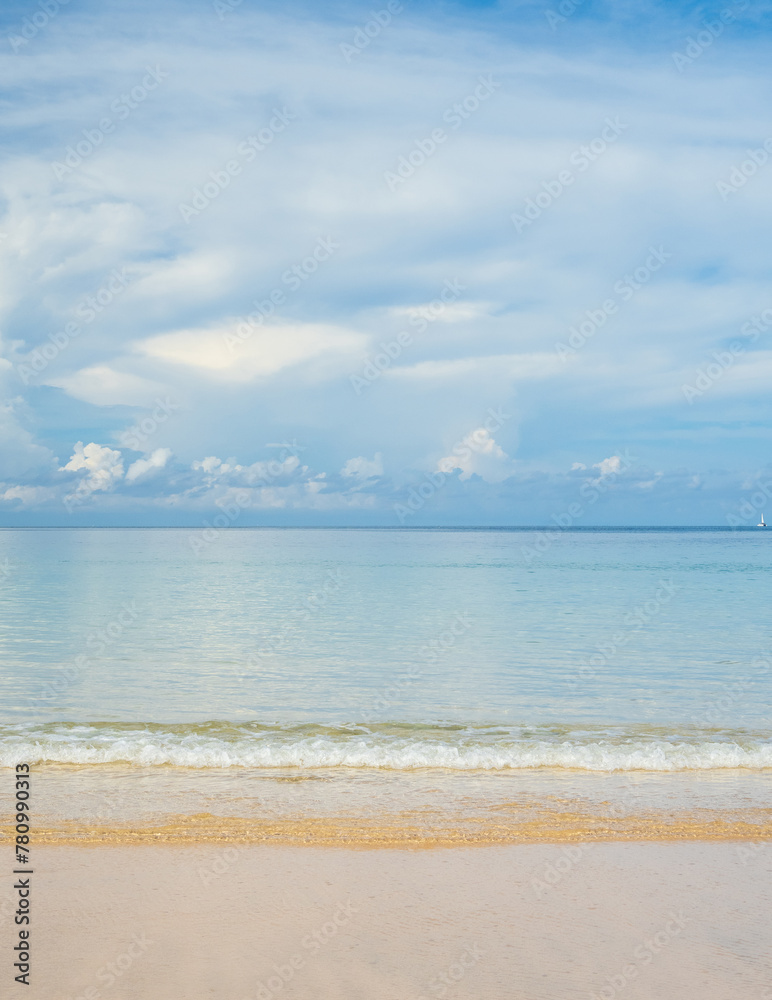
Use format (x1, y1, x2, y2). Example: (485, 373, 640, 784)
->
(9, 841, 772, 1000)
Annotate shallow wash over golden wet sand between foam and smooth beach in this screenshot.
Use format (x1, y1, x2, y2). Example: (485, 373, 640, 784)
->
(7, 765, 772, 849)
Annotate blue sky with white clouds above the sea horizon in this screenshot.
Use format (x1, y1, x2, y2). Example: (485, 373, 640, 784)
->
(0, 0, 772, 529)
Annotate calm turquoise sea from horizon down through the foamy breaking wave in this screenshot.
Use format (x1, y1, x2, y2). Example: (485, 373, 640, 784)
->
(0, 529, 772, 770)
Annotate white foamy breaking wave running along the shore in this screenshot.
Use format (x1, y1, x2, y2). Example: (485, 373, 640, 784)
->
(0, 726, 772, 772)
